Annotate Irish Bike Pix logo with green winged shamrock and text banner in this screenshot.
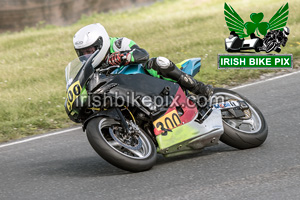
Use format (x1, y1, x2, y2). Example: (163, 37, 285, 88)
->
(218, 3, 292, 69)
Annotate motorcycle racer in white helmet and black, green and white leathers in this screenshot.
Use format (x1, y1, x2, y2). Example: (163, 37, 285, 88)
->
(73, 23, 213, 97)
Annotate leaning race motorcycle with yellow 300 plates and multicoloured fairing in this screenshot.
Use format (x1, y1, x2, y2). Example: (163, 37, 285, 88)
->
(65, 51, 268, 172)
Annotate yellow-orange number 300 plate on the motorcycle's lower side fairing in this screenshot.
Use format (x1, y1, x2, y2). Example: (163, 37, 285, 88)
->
(153, 110, 182, 131)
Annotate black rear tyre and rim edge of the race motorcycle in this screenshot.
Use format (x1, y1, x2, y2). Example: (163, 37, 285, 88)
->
(214, 88, 268, 149)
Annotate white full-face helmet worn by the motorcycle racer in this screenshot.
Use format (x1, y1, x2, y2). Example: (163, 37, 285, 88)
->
(73, 23, 110, 66)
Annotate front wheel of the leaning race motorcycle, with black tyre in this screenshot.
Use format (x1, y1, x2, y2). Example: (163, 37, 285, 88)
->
(86, 117, 157, 172)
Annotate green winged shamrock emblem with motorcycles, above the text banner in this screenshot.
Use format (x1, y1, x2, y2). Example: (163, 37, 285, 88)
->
(224, 3, 290, 53)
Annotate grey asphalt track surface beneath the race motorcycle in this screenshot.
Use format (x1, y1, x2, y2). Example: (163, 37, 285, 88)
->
(0, 72, 300, 200)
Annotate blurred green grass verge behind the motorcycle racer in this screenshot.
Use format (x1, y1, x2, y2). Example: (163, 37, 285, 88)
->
(0, 0, 300, 142)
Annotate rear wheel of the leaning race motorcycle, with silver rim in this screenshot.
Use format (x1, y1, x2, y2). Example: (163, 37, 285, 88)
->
(213, 88, 268, 149)
